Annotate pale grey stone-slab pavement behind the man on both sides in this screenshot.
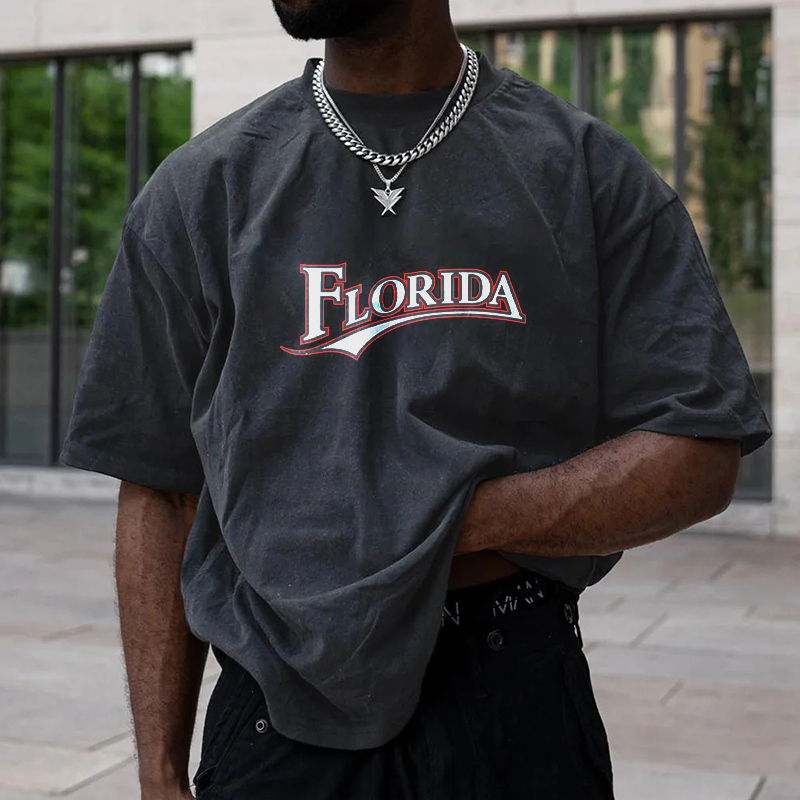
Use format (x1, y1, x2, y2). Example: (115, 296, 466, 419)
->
(0, 496, 800, 800)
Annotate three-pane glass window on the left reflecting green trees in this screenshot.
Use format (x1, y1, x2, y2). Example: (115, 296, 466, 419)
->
(0, 52, 194, 464)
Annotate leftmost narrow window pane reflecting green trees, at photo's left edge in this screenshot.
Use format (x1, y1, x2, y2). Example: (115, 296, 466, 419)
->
(0, 64, 54, 463)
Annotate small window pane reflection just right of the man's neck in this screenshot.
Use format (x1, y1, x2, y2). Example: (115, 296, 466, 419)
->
(495, 31, 576, 101)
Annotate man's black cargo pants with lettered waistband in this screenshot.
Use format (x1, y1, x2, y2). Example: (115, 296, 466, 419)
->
(195, 570, 613, 800)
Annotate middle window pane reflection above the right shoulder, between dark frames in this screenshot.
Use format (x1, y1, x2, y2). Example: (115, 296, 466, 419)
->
(591, 25, 675, 183)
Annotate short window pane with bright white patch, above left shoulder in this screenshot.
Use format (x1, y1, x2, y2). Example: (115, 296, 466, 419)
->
(139, 52, 194, 185)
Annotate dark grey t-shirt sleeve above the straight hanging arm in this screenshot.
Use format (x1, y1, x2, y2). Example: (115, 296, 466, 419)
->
(61, 220, 206, 494)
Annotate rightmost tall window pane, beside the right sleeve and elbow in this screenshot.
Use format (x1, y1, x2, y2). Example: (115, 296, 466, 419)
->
(686, 19, 772, 499)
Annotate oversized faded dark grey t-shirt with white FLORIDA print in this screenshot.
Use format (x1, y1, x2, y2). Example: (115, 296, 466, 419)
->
(62, 58, 769, 749)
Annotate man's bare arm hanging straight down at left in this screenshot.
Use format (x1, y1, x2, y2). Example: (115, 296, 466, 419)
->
(115, 481, 208, 800)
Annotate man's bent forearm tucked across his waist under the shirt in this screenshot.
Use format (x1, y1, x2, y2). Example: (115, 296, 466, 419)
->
(456, 431, 740, 556)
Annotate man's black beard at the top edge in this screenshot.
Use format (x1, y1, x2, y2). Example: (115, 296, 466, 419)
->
(272, 0, 397, 39)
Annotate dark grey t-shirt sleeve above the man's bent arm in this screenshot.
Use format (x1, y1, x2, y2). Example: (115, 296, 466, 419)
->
(599, 191, 771, 455)
